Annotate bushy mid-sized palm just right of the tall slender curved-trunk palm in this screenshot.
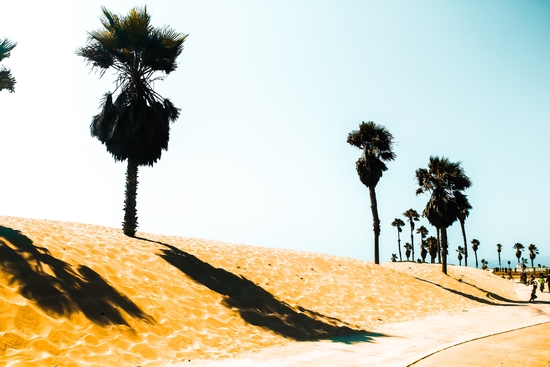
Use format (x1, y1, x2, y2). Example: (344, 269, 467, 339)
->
(416, 156, 472, 274)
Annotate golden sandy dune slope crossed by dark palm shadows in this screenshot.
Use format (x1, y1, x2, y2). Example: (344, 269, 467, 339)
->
(0, 217, 550, 367)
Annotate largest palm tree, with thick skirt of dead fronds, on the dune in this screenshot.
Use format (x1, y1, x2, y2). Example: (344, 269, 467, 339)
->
(76, 7, 187, 237)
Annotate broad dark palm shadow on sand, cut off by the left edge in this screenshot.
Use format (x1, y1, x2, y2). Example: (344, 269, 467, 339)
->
(0, 226, 156, 326)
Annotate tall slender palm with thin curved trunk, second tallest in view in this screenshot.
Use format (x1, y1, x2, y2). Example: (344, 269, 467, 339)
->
(347, 121, 396, 264)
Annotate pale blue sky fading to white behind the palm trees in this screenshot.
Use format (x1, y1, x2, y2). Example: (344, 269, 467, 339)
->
(0, 0, 550, 266)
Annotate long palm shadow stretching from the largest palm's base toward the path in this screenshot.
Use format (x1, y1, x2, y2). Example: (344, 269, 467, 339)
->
(148, 238, 385, 344)
